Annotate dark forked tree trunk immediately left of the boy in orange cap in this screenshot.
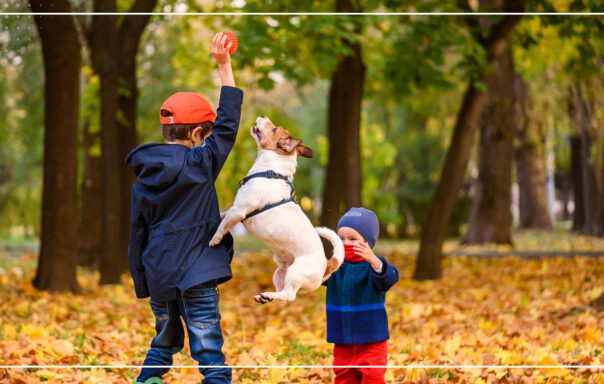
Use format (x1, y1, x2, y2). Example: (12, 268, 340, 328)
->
(89, 0, 157, 284)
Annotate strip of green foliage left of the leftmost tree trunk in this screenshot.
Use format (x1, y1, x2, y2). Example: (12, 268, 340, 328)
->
(0, 10, 44, 236)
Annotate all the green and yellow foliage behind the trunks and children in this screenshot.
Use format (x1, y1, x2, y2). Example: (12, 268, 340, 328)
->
(0, 0, 604, 240)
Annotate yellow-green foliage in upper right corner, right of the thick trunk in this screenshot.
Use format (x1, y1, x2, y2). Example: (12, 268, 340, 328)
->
(513, 9, 604, 183)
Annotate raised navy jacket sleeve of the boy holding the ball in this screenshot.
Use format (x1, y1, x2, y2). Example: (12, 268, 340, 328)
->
(194, 86, 243, 180)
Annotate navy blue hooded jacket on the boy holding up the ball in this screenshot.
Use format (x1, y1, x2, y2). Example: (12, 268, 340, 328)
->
(126, 87, 243, 301)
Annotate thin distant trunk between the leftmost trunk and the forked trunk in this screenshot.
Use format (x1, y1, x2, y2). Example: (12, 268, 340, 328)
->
(78, 124, 103, 269)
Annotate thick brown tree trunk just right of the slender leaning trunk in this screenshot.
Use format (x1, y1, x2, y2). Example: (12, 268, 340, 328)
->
(462, 47, 514, 244)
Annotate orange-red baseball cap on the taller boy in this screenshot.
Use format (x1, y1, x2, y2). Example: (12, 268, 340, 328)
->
(159, 92, 216, 124)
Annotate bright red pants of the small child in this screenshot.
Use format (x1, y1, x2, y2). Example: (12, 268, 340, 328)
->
(333, 341, 388, 384)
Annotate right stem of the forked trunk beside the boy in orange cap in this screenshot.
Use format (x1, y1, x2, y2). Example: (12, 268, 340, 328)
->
(116, 0, 157, 280)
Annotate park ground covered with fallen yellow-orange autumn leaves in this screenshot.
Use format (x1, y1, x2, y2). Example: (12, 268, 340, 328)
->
(0, 230, 604, 384)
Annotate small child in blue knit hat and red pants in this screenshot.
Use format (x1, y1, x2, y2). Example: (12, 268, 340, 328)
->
(326, 208, 398, 384)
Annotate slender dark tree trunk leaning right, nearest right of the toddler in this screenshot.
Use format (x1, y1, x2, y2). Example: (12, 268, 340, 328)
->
(413, 6, 524, 280)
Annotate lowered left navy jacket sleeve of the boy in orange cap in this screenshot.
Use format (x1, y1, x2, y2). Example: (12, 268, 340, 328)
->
(128, 188, 150, 299)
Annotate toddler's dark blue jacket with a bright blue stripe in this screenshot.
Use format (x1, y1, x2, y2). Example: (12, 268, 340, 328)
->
(325, 256, 398, 344)
